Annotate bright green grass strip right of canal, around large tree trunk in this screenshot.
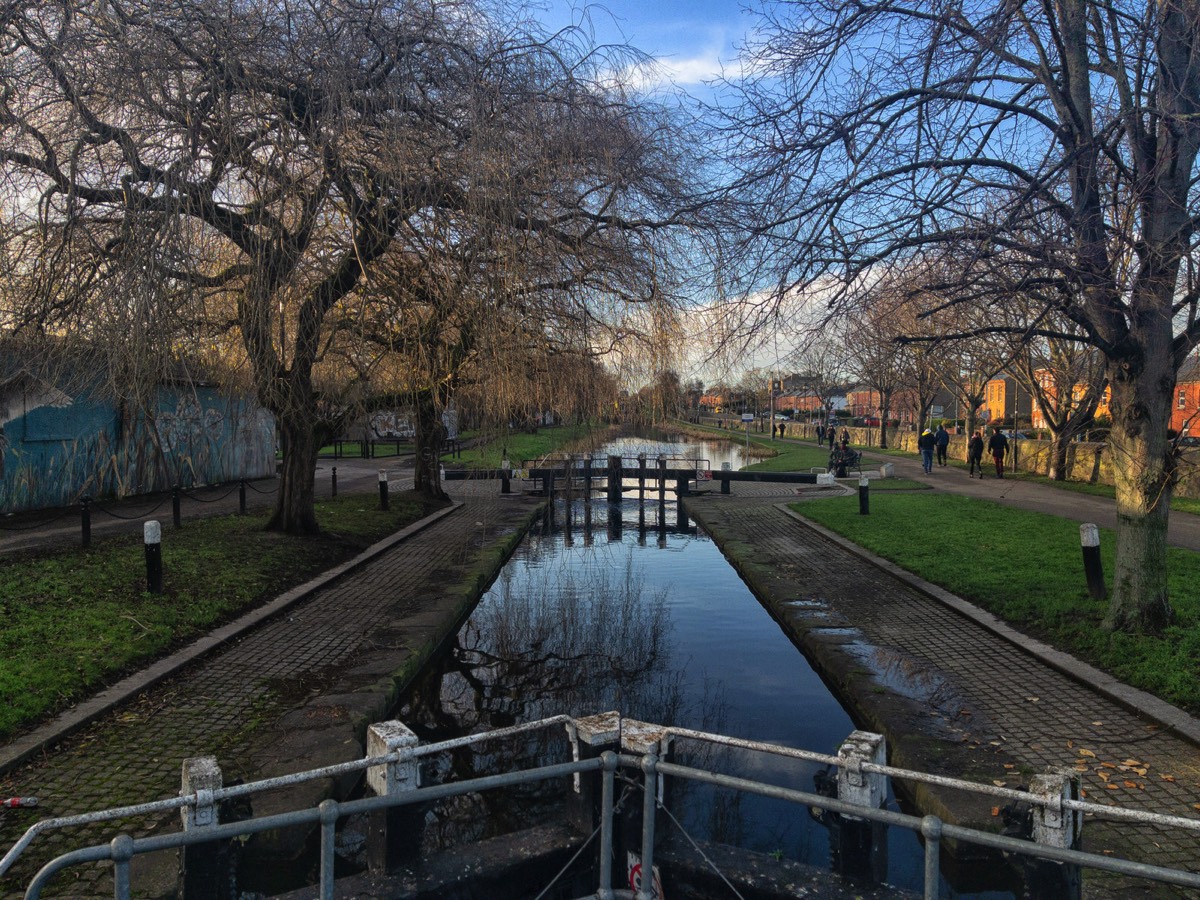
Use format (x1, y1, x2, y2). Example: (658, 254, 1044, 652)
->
(793, 490, 1200, 714)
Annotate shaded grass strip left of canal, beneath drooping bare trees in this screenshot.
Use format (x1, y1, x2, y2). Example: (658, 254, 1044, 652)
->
(0, 493, 426, 738)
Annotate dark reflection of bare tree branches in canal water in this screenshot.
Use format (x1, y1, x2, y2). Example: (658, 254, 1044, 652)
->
(401, 552, 710, 847)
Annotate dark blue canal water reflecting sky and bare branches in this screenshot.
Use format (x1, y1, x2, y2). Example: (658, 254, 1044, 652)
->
(398, 440, 1012, 898)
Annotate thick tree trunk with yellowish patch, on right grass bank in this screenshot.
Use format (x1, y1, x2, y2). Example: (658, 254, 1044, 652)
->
(1104, 353, 1176, 634)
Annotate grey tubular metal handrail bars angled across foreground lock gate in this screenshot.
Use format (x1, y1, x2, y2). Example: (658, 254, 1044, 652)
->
(9, 713, 1200, 898)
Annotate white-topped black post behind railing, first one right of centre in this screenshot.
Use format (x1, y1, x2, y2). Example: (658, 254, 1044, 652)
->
(829, 731, 888, 884)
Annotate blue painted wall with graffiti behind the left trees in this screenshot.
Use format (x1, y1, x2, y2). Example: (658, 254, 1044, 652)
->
(0, 379, 275, 512)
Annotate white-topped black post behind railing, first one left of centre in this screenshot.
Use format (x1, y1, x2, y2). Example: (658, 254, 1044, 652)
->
(367, 721, 425, 875)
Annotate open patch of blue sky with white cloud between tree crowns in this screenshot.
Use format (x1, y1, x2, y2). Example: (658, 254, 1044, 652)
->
(539, 0, 750, 94)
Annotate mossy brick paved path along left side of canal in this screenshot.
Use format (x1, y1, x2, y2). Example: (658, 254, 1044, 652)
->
(0, 482, 533, 896)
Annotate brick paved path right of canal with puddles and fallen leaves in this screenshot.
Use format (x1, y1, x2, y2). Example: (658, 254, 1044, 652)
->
(688, 484, 1200, 896)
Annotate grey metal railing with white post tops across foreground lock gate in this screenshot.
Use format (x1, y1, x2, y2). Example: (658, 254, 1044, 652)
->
(9, 713, 1200, 900)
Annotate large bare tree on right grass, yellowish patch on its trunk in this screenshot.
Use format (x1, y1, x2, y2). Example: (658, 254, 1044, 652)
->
(728, 0, 1200, 631)
